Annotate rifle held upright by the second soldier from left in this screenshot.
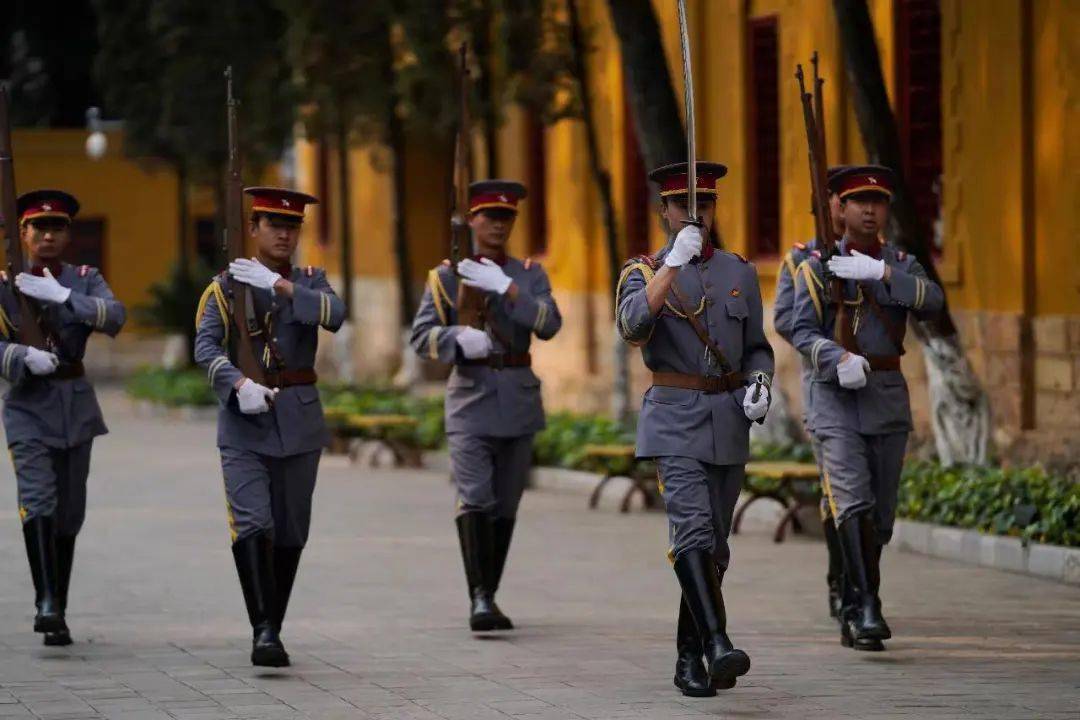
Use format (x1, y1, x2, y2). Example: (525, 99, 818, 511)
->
(221, 65, 269, 384)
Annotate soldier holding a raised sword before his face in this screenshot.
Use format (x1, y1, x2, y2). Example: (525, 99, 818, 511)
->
(616, 162, 773, 696)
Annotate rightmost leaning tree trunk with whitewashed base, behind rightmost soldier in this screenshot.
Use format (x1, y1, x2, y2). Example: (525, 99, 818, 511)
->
(833, 0, 990, 464)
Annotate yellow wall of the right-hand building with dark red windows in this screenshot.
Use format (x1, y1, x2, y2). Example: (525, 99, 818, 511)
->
(291, 0, 1080, 323)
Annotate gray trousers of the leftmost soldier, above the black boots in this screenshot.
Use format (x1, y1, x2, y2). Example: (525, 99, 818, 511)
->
(9, 440, 93, 535)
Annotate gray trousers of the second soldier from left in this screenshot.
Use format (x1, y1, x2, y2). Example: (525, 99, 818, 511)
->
(220, 448, 323, 547)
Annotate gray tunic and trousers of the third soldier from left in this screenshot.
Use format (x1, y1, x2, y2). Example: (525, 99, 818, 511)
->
(410, 258, 563, 518)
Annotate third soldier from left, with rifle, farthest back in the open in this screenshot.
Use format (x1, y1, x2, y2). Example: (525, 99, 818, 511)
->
(411, 180, 563, 631)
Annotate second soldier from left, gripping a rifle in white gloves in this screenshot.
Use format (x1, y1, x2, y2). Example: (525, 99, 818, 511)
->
(195, 188, 346, 667)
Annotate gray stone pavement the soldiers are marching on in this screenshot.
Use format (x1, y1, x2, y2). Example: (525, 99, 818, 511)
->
(0, 394, 1080, 720)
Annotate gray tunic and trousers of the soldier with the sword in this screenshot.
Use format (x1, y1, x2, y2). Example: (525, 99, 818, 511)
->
(616, 242, 773, 570)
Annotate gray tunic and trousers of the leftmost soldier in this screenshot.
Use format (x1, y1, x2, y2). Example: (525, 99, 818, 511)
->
(0, 263, 126, 536)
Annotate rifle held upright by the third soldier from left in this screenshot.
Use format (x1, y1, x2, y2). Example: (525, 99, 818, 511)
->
(450, 43, 486, 330)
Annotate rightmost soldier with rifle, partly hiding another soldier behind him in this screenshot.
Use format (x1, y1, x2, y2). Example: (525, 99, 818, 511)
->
(793, 165, 944, 650)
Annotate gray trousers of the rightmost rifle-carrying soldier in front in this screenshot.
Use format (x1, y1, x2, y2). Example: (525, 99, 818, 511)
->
(818, 430, 907, 545)
